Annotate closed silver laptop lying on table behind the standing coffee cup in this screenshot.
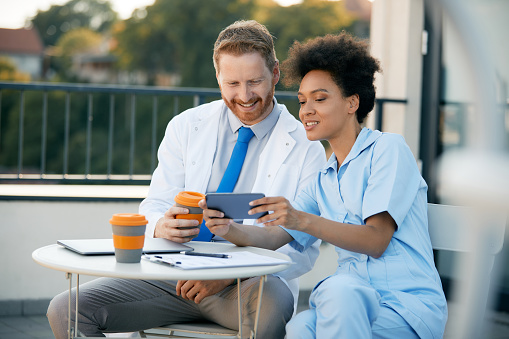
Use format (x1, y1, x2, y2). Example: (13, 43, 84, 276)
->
(57, 238, 194, 255)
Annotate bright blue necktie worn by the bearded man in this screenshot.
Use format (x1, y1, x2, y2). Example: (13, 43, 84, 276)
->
(193, 127, 254, 241)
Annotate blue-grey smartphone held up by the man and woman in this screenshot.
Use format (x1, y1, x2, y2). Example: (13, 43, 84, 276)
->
(205, 193, 268, 220)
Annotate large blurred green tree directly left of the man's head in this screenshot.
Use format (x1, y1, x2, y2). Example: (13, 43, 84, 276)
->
(114, 0, 255, 87)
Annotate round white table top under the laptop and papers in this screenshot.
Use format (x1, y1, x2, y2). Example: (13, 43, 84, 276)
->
(32, 241, 291, 280)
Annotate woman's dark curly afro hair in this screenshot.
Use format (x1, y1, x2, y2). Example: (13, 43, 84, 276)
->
(281, 32, 381, 123)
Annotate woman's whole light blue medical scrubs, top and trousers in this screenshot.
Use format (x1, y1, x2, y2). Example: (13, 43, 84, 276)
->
(286, 128, 447, 339)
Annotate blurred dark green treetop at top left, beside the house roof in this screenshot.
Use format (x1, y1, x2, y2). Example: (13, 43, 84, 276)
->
(30, 0, 118, 46)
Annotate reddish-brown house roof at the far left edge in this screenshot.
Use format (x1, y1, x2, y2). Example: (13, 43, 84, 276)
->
(0, 28, 44, 54)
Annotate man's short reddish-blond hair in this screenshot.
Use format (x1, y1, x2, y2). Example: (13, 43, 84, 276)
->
(213, 20, 277, 73)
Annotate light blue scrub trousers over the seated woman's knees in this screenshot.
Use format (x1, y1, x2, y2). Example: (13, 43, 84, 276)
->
(286, 274, 419, 339)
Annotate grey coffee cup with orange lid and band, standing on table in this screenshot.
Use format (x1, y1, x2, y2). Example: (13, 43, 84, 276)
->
(110, 213, 148, 263)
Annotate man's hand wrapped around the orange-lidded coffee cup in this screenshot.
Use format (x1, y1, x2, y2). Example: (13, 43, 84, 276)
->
(154, 206, 200, 243)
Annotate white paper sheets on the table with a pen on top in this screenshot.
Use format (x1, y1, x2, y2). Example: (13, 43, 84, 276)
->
(143, 251, 291, 270)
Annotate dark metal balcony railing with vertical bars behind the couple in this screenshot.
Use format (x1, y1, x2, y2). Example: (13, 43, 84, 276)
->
(0, 82, 406, 184)
